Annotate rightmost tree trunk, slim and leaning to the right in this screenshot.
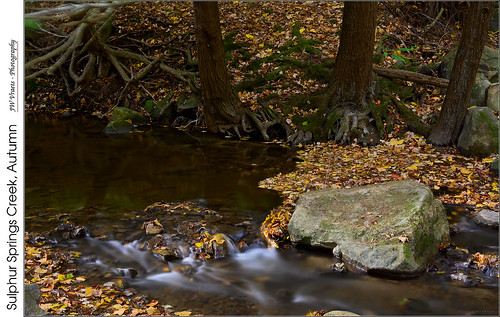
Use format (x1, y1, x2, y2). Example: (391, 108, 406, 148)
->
(427, 2, 494, 145)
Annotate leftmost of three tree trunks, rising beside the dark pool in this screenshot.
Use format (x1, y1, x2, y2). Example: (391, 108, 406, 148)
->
(194, 1, 242, 133)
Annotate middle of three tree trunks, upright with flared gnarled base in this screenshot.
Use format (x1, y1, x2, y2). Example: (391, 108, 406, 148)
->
(326, 2, 378, 144)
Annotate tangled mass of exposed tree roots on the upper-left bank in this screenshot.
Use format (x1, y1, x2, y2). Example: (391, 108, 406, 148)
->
(25, 2, 200, 97)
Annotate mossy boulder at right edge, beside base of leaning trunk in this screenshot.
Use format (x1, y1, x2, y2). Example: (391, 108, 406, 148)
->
(457, 107, 498, 157)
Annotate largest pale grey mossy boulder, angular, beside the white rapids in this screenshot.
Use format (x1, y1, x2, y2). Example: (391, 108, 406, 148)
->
(288, 181, 449, 275)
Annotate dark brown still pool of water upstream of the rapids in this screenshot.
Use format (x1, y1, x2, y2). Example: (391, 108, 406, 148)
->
(26, 113, 293, 230)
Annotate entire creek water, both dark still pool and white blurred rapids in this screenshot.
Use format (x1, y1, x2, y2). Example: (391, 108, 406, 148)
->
(25, 117, 498, 315)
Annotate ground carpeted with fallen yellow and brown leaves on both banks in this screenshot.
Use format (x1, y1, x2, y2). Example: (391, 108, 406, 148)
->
(25, 1, 499, 316)
